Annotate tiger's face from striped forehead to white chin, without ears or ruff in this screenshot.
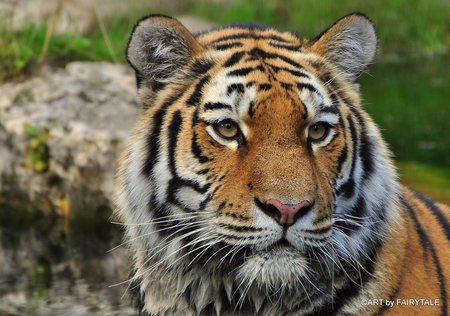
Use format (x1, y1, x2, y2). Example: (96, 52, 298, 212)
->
(188, 52, 344, 284)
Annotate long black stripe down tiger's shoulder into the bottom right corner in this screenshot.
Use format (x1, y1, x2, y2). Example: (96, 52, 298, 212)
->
(402, 197, 448, 315)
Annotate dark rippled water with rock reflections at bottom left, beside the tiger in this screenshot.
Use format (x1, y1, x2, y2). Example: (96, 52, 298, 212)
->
(0, 209, 133, 316)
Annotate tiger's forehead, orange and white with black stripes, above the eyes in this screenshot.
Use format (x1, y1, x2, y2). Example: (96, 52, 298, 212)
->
(193, 49, 332, 121)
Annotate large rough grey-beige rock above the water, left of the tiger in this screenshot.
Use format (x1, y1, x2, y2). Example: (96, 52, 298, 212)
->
(0, 62, 140, 217)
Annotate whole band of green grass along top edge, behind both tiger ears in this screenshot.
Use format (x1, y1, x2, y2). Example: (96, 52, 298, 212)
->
(0, 0, 450, 81)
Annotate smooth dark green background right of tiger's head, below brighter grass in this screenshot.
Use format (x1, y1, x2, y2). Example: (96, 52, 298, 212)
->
(361, 56, 450, 167)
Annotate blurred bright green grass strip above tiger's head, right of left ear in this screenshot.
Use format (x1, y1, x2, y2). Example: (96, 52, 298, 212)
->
(184, 0, 450, 54)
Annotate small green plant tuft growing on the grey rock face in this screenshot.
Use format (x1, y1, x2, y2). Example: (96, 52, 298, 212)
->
(24, 124, 49, 172)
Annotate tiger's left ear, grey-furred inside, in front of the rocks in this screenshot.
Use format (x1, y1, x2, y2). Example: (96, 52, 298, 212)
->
(125, 15, 201, 94)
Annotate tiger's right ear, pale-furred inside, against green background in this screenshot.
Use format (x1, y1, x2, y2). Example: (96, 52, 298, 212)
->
(312, 13, 378, 82)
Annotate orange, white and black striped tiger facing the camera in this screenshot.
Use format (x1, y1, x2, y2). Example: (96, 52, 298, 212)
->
(114, 13, 450, 316)
